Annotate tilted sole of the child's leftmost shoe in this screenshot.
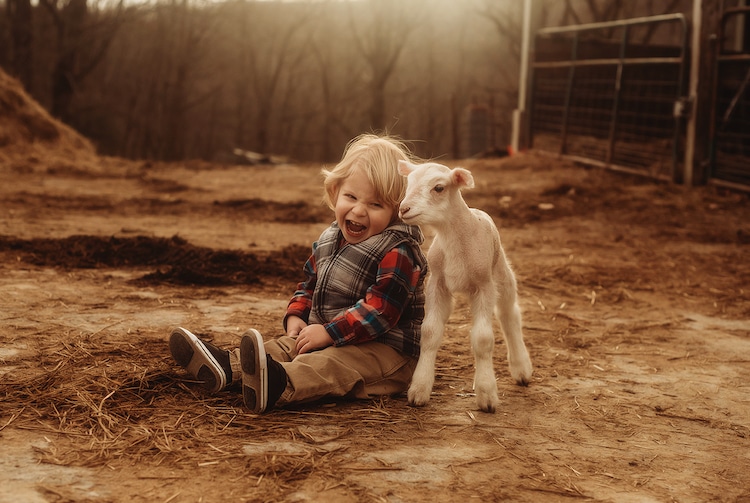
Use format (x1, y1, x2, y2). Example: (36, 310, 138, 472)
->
(169, 327, 227, 393)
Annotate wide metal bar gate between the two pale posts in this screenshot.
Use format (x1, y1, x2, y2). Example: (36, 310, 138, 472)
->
(528, 14, 690, 180)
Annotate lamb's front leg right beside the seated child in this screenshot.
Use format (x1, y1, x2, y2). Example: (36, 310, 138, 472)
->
(407, 272, 453, 406)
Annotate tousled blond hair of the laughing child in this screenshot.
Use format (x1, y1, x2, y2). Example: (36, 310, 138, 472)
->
(322, 134, 414, 219)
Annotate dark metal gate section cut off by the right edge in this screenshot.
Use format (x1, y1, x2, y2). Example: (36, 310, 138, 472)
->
(711, 7, 750, 187)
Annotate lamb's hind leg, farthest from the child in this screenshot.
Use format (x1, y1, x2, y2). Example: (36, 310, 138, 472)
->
(497, 268, 533, 386)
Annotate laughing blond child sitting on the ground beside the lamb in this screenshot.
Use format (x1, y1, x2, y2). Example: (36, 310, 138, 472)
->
(169, 134, 427, 414)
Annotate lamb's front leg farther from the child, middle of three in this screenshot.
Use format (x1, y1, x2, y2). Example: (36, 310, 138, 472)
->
(471, 284, 499, 412)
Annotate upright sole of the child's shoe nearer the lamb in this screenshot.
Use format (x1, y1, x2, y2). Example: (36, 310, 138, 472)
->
(240, 328, 268, 414)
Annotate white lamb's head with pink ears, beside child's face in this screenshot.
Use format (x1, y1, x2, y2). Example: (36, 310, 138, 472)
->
(398, 161, 474, 225)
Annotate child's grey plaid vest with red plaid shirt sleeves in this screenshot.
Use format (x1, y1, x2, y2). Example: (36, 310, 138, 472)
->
(284, 222, 427, 357)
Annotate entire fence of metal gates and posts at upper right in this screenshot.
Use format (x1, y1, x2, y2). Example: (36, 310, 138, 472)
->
(512, 0, 750, 190)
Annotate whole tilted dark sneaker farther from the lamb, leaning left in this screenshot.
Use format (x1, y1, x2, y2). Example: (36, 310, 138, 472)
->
(169, 327, 239, 393)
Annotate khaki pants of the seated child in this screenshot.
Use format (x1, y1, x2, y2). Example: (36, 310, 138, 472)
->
(264, 335, 417, 407)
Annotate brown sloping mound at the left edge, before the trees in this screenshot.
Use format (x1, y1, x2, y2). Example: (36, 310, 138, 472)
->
(0, 70, 98, 171)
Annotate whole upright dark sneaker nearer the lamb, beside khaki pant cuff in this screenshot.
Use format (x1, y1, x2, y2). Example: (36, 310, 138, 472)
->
(240, 328, 286, 414)
